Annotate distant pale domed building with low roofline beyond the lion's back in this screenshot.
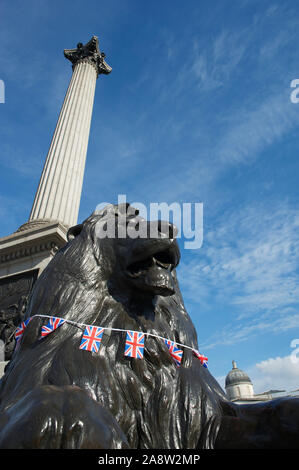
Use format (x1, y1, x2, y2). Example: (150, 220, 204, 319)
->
(225, 361, 272, 403)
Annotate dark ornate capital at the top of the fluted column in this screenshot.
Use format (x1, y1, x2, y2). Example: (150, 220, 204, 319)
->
(63, 36, 112, 75)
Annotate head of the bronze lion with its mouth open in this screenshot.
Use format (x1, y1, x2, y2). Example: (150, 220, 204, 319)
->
(68, 204, 180, 296)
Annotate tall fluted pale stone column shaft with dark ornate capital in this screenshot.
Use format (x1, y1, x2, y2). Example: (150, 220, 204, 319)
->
(29, 36, 111, 226)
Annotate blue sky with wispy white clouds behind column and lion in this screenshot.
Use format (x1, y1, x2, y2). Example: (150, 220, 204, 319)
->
(0, 0, 299, 392)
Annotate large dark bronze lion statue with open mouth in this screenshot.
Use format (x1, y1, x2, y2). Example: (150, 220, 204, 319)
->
(0, 204, 299, 449)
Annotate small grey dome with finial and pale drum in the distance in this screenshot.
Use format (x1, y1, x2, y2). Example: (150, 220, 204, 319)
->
(225, 361, 254, 400)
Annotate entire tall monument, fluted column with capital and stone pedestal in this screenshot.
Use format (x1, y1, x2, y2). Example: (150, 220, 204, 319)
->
(0, 36, 111, 361)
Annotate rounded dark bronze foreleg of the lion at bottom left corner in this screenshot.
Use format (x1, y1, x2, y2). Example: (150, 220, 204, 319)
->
(0, 385, 128, 449)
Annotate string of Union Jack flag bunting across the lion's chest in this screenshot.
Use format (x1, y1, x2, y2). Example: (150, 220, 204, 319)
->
(15, 314, 208, 367)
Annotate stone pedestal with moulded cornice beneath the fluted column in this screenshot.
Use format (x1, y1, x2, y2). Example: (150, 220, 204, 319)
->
(0, 220, 68, 361)
